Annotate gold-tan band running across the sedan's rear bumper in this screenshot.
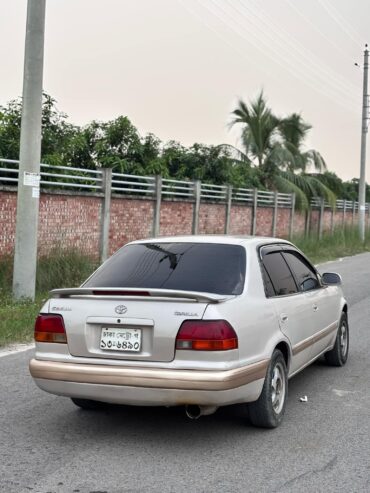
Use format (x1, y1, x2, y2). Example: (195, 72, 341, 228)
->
(30, 359, 270, 390)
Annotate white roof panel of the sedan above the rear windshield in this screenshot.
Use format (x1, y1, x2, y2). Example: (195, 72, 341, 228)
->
(130, 235, 291, 247)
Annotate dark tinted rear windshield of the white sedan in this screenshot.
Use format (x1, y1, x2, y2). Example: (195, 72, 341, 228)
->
(84, 243, 246, 294)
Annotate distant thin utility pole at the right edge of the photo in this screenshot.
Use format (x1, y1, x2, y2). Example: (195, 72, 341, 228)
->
(358, 44, 369, 241)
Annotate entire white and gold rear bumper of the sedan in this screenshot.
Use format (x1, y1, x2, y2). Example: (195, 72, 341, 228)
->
(30, 359, 269, 406)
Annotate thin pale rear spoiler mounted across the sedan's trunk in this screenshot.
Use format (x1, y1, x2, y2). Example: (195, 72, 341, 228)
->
(50, 287, 235, 303)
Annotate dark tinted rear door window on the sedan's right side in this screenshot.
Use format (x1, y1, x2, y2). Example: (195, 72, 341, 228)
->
(262, 252, 297, 296)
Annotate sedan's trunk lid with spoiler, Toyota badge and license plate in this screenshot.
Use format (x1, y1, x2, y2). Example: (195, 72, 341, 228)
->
(49, 288, 233, 362)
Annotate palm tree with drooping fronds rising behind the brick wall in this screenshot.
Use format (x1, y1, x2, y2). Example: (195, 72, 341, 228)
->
(231, 92, 335, 209)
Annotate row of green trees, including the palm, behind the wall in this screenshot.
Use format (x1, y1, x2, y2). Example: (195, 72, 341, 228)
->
(0, 92, 370, 195)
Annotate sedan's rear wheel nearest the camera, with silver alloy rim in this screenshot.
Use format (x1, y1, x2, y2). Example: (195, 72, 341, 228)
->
(248, 349, 288, 428)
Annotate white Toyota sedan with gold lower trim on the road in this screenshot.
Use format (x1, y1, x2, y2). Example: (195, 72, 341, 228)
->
(30, 236, 348, 428)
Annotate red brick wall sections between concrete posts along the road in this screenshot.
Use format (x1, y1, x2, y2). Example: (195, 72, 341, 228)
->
(0, 187, 369, 257)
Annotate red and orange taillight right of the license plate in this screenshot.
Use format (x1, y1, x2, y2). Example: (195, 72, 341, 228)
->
(176, 320, 238, 351)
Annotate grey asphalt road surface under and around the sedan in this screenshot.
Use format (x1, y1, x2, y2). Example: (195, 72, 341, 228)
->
(0, 254, 370, 493)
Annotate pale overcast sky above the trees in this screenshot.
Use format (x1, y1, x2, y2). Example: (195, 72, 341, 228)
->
(0, 0, 370, 182)
